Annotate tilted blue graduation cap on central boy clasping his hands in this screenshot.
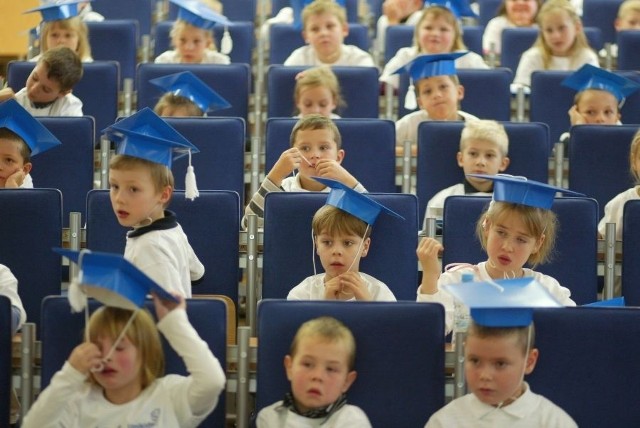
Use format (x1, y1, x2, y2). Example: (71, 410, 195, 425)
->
(312, 177, 404, 225)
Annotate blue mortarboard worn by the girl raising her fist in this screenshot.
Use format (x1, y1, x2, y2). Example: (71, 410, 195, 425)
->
(467, 174, 584, 210)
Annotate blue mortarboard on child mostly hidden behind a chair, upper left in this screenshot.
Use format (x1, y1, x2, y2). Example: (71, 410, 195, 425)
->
(149, 71, 231, 113)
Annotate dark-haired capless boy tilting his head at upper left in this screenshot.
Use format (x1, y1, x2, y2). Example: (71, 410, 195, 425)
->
(0, 46, 82, 116)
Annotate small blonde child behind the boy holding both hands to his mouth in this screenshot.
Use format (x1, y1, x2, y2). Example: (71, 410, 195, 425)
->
(294, 66, 344, 119)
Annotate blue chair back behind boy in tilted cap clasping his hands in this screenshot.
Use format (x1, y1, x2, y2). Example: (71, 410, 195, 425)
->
(262, 192, 418, 300)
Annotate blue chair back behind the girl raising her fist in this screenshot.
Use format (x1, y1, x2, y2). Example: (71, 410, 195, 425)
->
(442, 196, 598, 305)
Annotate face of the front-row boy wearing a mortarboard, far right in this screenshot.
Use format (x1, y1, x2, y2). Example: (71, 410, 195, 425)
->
(464, 335, 538, 406)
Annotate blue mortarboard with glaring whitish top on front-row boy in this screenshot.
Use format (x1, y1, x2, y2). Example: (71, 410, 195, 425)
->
(442, 278, 562, 327)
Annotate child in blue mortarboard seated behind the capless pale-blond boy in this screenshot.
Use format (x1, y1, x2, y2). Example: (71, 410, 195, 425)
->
(395, 52, 478, 147)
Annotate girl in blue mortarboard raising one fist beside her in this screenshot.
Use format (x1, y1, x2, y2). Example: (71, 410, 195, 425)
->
(417, 174, 576, 334)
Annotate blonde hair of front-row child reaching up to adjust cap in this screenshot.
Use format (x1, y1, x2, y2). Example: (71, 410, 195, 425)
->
(87, 306, 165, 389)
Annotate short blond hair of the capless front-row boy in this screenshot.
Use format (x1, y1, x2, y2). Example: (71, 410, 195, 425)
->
(289, 317, 356, 371)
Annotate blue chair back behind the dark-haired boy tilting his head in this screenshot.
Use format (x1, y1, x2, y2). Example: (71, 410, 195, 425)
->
(7, 61, 120, 136)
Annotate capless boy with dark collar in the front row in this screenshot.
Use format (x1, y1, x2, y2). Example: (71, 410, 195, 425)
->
(256, 317, 371, 428)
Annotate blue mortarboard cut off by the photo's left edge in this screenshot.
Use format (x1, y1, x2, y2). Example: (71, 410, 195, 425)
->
(0, 99, 62, 156)
